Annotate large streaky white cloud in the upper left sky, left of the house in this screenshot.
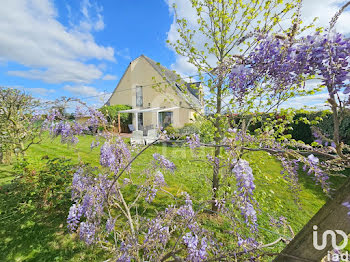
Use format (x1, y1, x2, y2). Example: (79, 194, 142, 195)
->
(0, 0, 115, 83)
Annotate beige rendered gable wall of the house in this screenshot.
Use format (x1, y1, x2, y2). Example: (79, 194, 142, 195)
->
(109, 56, 194, 127)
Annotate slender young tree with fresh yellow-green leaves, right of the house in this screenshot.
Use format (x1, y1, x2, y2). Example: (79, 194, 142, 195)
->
(168, 0, 300, 212)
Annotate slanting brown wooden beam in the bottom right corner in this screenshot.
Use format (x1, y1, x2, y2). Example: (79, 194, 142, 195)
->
(274, 178, 350, 262)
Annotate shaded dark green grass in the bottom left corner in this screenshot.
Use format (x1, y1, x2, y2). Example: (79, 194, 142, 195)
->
(0, 184, 103, 261)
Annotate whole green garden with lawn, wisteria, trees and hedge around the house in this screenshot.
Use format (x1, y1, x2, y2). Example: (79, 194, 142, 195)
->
(0, 0, 350, 261)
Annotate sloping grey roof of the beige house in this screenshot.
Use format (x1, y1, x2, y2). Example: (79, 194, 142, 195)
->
(141, 55, 202, 108)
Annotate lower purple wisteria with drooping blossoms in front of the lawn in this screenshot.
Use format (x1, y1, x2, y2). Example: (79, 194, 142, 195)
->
(44, 100, 292, 261)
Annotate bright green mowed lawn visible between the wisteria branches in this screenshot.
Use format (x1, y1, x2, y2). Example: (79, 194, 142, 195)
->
(0, 136, 343, 261)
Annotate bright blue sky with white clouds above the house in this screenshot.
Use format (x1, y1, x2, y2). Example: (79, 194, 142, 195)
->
(0, 0, 350, 106)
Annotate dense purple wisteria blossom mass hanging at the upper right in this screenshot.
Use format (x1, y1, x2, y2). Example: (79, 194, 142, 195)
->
(229, 32, 350, 101)
